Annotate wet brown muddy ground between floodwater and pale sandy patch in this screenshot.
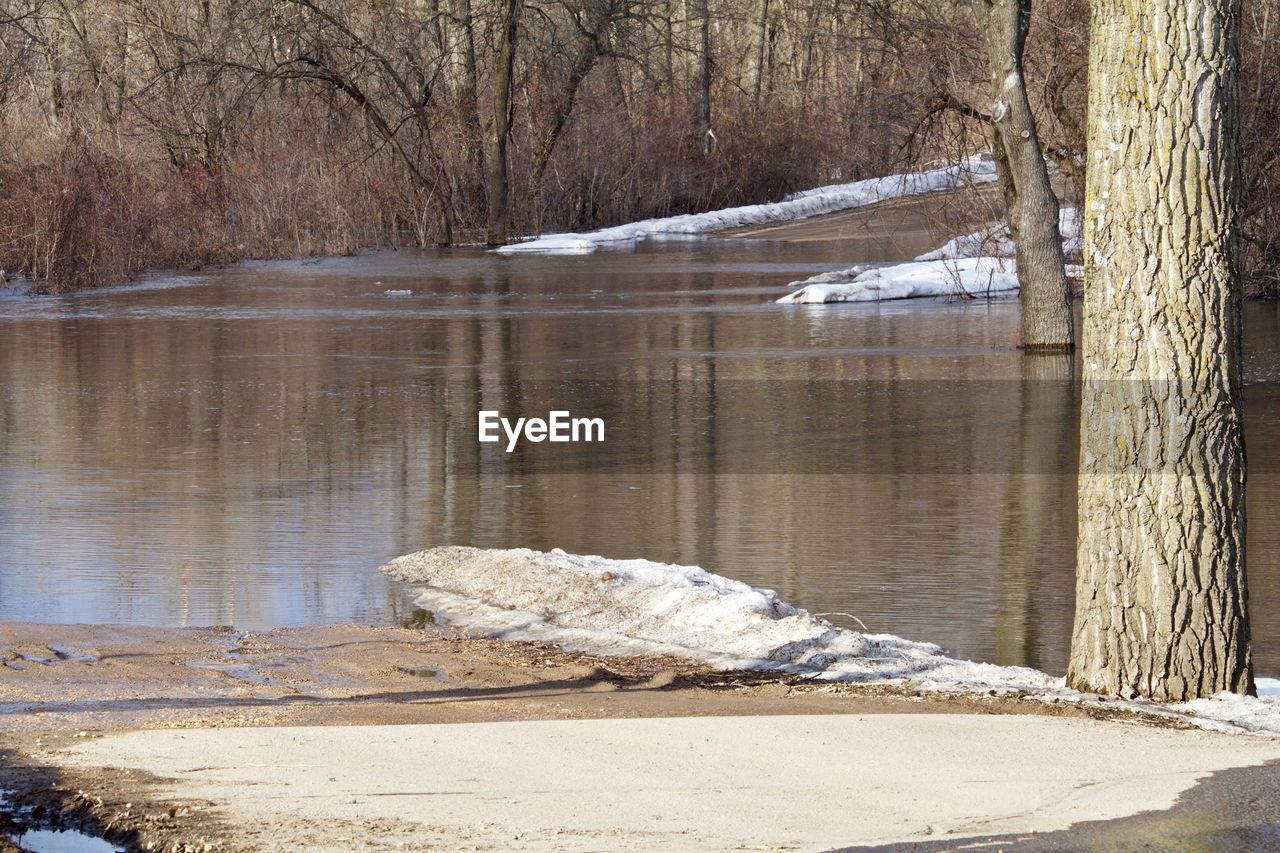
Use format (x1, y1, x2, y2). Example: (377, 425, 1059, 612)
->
(0, 622, 1264, 849)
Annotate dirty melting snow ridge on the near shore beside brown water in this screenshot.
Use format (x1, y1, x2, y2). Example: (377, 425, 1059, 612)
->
(383, 546, 1280, 734)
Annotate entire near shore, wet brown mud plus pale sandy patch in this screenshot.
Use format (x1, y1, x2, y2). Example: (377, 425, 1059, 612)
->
(0, 624, 1280, 850)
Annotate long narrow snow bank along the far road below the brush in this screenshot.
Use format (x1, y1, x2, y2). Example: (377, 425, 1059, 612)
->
(494, 155, 996, 255)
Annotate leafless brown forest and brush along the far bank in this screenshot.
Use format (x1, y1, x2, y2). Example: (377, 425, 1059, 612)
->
(0, 0, 1280, 292)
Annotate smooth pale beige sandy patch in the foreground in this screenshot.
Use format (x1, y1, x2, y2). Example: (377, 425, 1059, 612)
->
(61, 713, 1280, 850)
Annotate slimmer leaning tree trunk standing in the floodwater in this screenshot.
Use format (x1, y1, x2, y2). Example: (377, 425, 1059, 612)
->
(972, 0, 1075, 351)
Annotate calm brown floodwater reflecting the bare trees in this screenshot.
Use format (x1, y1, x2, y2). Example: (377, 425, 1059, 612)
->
(0, 230, 1280, 674)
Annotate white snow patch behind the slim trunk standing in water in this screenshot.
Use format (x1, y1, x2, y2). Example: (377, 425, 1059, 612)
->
(778, 207, 1084, 305)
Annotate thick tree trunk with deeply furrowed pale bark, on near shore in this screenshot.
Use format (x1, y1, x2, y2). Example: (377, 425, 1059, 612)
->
(1068, 0, 1253, 701)
